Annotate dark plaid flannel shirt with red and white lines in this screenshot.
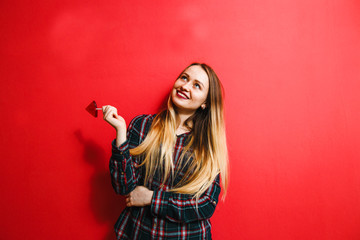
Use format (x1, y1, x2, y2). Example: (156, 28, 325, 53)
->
(110, 114, 221, 240)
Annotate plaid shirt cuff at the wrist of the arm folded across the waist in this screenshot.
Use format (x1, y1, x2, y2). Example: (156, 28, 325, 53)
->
(150, 189, 171, 218)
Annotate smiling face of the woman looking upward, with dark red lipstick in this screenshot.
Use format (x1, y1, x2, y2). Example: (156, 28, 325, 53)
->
(171, 65, 209, 114)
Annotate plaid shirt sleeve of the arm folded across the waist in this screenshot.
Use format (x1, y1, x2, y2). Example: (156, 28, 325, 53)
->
(150, 175, 221, 223)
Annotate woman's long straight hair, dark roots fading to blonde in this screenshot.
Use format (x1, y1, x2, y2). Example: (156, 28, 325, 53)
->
(130, 63, 229, 199)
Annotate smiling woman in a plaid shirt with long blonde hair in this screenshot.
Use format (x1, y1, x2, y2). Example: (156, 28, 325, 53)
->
(103, 63, 228, 239)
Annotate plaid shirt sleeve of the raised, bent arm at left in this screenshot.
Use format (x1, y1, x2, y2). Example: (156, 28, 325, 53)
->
(109, 115, 143, 195)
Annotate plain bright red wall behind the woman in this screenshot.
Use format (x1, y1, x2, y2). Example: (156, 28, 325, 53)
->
(0, 0, 360, 240)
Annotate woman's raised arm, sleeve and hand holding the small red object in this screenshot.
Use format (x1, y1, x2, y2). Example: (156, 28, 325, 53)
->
(103, 106, 140, 195)
